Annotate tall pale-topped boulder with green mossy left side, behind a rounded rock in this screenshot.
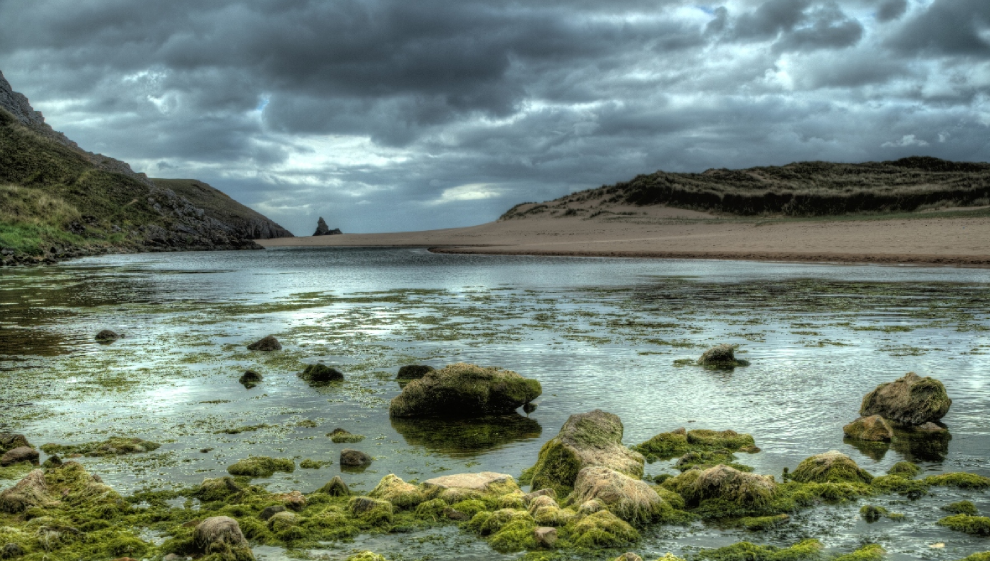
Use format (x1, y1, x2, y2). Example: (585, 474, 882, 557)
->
(532, 409, 645, 497)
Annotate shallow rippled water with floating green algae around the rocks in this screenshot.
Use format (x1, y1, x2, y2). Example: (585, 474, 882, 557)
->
(0, 249, 990, 559)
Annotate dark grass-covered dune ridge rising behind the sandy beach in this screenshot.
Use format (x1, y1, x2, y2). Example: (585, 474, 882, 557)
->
(500, 157, 990, 220)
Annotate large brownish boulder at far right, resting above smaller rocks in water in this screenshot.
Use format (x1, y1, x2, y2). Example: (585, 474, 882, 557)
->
(859, 372, 952, 426)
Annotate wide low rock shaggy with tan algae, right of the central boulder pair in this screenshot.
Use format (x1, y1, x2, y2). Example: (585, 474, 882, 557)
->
(684, 466, 777, 507)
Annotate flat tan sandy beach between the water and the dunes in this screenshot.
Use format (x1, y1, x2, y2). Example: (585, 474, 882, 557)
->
(258, 207, 990, 267)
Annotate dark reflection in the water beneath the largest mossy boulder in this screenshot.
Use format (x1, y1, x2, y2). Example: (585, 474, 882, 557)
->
(392, 413, 543, 457)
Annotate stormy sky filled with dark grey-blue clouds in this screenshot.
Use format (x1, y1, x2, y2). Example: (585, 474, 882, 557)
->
(0, 0, 990, 235)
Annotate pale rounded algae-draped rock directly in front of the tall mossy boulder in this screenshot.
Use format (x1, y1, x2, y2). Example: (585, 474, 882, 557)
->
(571, 466, 671, 524)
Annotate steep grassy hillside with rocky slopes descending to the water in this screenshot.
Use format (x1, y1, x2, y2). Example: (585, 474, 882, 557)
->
(0, 68, 292, 266)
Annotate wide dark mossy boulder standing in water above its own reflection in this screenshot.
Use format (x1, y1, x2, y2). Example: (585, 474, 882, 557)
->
(389, 363, 543, 417)
